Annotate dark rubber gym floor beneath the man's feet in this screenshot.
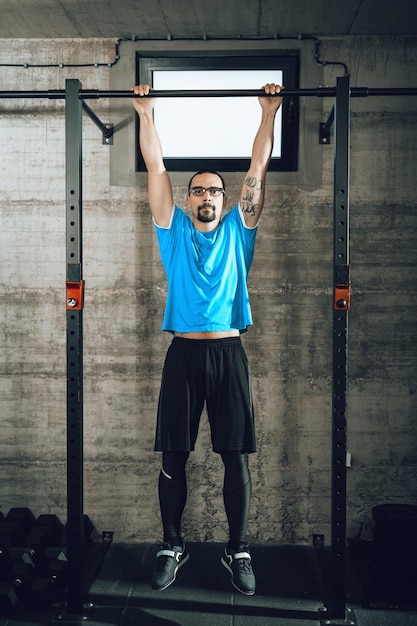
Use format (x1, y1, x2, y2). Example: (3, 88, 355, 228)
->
(0, 543, 417, 626)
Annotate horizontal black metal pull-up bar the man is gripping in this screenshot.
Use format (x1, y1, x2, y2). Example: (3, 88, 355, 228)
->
(0, 87, 417, 100)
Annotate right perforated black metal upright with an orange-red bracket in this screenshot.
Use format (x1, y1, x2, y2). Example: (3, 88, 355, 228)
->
(326, 76, 354, 624)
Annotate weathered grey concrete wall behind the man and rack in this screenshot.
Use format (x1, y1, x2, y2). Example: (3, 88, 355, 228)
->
(0, 38, 417, 543)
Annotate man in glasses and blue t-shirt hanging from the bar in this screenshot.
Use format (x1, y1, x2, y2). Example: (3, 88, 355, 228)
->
(132, 83, 282, 595)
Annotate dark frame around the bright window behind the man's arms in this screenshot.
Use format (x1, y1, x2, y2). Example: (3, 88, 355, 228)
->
(136, 50, 299, 172)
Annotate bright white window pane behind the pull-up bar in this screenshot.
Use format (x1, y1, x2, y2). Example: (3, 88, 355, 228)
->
(153, 69, 283, 158)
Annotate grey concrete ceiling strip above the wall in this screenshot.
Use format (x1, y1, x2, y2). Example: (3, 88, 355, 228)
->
(0, 0, 417, 39)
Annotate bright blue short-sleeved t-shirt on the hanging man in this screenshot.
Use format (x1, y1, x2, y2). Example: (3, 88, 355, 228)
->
(155, 204, 257, 333)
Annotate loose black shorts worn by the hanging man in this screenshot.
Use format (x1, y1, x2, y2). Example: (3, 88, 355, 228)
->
(155, 337, 256, 452)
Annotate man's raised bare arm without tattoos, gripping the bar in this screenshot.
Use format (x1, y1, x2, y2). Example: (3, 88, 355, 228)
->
(132, 85, 174, 228)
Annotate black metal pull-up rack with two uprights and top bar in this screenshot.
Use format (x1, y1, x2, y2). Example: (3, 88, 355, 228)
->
(0, 75, 417, 626)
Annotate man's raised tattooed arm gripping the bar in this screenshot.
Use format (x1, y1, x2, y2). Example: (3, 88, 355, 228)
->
(240, 83, 283, 228)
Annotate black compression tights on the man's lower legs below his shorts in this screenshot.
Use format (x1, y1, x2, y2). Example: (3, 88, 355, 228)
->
(159, 451, 252, 549)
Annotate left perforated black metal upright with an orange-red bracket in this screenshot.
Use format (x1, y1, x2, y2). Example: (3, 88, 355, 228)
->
(65, 80, 84, 615)
